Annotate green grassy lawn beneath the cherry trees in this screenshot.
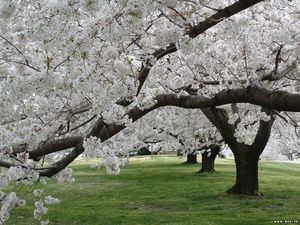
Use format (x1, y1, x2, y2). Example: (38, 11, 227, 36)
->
(7, 156, 300, 225)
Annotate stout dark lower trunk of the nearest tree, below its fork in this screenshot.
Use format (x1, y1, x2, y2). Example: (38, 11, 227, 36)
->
(227, 148, 260, 195)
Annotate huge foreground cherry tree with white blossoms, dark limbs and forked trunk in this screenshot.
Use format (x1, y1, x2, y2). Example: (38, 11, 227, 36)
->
(0, 0, 300, 224)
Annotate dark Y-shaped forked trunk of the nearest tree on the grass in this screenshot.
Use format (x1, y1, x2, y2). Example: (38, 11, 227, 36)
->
(202, 107, 274, 195)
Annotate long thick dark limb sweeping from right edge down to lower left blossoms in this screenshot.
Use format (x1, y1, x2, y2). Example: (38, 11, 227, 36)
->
(35, 86, 300, 176)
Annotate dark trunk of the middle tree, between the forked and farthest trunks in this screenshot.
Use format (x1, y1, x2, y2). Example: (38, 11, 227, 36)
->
(197, 145, 220, 173)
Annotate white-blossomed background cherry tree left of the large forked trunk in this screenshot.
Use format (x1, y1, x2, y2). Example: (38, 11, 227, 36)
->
(142, 108, 223, 169)
